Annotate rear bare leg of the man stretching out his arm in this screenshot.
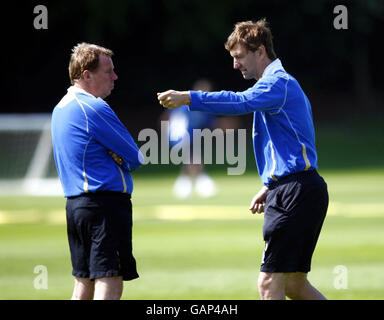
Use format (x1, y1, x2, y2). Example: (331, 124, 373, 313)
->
(285, 272, 327, 300)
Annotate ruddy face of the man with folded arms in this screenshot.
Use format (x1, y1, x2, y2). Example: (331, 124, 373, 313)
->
(89, 54, 117, 99)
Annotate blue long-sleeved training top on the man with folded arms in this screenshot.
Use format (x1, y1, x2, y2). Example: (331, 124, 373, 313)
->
(51, 86, 144, 197)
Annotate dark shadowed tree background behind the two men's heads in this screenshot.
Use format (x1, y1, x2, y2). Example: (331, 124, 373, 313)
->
(1, 0, 384, 138)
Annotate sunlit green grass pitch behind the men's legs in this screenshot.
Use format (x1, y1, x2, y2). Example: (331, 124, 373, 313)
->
(0, 169, 384, 300)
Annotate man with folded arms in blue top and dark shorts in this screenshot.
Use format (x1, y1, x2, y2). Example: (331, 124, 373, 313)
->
(52, 43, 144, 300)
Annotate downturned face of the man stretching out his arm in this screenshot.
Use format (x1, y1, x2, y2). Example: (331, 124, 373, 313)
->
(229, 44, 260, 80)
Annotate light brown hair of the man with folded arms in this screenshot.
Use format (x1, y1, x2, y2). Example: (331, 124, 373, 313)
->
(68, 42, 113, 85)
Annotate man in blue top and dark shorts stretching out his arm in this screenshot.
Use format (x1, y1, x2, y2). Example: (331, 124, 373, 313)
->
(158, 19, 328, 299)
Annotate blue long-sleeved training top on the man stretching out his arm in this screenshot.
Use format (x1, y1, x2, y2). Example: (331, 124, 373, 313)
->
(189, 59, 317, 186)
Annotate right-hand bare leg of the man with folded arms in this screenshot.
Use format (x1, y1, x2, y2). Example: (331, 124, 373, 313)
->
(94, 277, 123, 300)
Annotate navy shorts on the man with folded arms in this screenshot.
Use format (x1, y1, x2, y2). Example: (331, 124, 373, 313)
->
(66, 192, 139, 280)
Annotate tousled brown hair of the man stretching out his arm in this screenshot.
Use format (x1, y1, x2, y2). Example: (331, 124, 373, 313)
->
(225, 18, 276, 60)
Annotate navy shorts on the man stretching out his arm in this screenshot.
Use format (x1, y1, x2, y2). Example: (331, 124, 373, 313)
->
(260, 170, 329, 273)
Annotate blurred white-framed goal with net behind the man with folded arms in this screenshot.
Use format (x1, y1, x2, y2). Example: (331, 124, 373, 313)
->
(0, 113, 63, 196)
